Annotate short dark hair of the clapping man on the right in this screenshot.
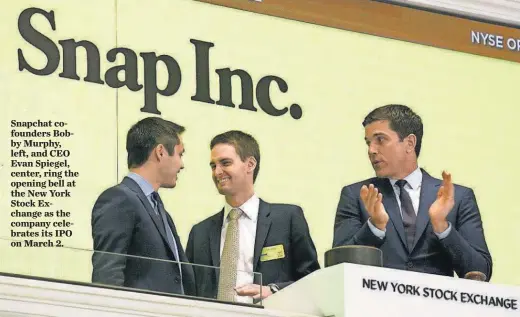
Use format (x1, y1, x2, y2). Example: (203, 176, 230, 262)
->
(363, 104, 423, 157)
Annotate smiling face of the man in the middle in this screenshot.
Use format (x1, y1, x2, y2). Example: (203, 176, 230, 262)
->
(209, 143, 256, 196)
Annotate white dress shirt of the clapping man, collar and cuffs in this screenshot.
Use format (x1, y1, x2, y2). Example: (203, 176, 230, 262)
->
(368, 167, 451, 239)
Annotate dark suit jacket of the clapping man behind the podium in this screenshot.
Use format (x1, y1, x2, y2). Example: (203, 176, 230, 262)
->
(333, 170, 492, 280)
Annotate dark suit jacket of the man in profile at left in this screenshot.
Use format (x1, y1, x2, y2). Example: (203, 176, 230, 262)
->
(92, 177, 194, 295)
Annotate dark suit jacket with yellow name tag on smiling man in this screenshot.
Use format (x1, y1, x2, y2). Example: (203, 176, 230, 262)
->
(186, 200, 320, 298)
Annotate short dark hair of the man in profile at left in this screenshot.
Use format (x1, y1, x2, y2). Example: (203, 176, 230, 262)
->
(126, 117, 185, 168)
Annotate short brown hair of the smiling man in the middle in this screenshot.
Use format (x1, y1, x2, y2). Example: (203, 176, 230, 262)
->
(209, 130, 260, 183)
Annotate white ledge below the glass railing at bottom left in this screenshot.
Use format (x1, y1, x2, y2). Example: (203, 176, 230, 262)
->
(0, 276, 314, 317)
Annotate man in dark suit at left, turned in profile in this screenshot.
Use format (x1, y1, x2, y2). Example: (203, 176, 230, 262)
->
(92, 117, 194, 295)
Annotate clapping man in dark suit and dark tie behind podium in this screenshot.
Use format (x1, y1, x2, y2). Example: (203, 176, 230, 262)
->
(333, 105, 492, 280)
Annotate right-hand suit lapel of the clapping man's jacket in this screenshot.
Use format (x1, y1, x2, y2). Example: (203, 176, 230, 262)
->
(410, 169, 441, 252)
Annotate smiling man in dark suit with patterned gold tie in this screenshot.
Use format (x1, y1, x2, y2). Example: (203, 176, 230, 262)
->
(186, 131, 319, 303)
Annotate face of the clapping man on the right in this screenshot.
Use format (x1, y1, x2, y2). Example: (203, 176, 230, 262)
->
(365, 120, 410, 178)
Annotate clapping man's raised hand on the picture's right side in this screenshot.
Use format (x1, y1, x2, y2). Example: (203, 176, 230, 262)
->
(429, 171, 455, 233)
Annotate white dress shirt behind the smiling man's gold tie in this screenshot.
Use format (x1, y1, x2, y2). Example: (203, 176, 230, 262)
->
(220, 194, 260, 303)
